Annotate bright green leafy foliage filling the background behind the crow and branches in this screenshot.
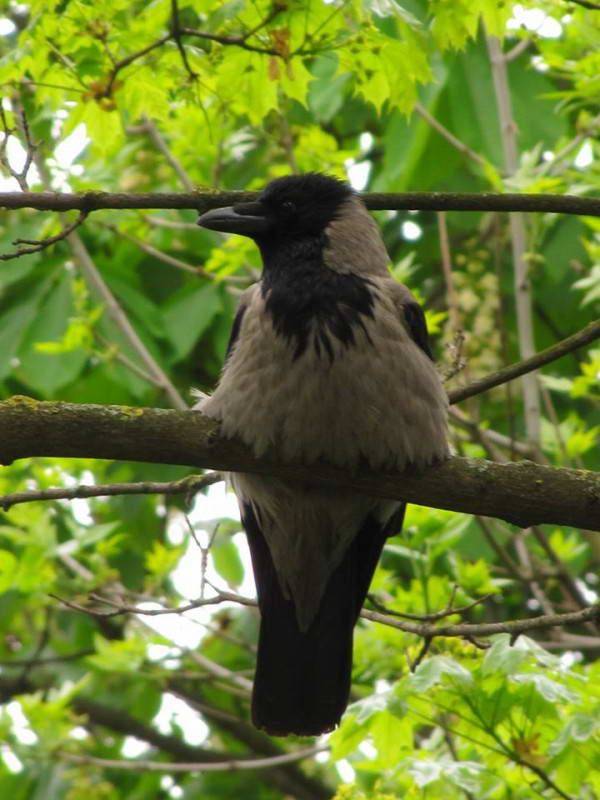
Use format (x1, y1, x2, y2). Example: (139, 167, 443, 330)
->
(0, 0, 600, 800)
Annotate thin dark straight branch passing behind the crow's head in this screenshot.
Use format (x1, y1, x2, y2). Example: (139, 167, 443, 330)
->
(0, 191, 600, 217)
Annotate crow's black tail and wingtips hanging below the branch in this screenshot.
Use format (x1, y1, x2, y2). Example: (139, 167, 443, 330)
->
(244, 506, 401, 736)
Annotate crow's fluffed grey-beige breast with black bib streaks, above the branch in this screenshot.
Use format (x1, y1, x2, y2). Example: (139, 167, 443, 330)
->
(199, 276, 447, 469)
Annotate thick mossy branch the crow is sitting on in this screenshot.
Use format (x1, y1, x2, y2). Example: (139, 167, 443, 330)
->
(0, 397, 600, 531)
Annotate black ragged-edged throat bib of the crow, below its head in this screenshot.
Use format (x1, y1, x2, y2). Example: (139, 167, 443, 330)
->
(260, 234, 373, 361)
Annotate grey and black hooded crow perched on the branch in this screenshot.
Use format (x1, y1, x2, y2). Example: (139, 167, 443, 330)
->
(196, 173, 448, 736)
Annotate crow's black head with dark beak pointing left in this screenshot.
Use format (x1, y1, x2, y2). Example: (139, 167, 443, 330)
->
(198, 172, 353, 243)
